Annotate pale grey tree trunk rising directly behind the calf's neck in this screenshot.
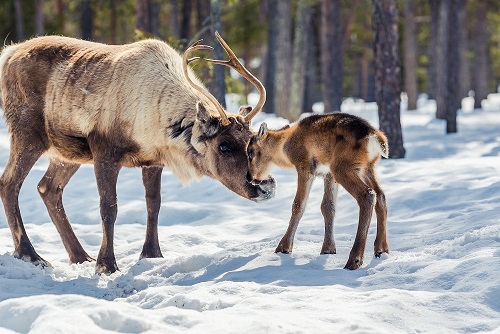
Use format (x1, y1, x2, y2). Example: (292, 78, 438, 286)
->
(271, 0, 292, 120)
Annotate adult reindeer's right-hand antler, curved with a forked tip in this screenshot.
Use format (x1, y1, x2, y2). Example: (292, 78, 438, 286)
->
(204, 31, 266, 122)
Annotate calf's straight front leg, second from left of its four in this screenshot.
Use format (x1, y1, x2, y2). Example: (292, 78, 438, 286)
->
(321, 173, 339, 254)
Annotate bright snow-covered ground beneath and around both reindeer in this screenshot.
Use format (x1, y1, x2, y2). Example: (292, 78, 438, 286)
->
(0, 101, 500, 333)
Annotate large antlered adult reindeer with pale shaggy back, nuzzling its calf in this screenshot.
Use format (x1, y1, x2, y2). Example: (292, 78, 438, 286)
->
(0, 33, 275, 273)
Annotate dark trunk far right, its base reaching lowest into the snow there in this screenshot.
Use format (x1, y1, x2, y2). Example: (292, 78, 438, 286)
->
(445, 0, 465, 133)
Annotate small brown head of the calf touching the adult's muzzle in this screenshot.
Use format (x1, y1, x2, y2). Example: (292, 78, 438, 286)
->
(247, 123, 275, 196)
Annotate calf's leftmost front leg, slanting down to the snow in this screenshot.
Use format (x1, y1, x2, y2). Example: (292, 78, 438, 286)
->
(274, 172, 314, 254)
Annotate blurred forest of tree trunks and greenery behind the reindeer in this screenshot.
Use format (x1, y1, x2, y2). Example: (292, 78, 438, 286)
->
(0, 0, 500, 157)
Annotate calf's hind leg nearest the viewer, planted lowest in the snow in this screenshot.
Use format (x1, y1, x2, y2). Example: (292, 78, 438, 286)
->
(334, 167, 377, 270)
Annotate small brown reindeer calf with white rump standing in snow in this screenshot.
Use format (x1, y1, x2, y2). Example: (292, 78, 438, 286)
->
(247, 113, 389, 270)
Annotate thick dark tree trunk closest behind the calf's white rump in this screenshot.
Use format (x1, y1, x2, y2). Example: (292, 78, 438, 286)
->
(373, 0, 405, 158)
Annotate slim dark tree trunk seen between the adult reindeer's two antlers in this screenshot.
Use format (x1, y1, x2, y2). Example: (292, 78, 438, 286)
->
(209, 0, 226, 108)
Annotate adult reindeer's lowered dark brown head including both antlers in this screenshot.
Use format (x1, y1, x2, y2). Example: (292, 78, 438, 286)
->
(183, 32, 276, 202)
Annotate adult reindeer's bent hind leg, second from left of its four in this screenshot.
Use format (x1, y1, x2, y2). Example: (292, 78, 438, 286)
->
(38, 160, 94, 263)
